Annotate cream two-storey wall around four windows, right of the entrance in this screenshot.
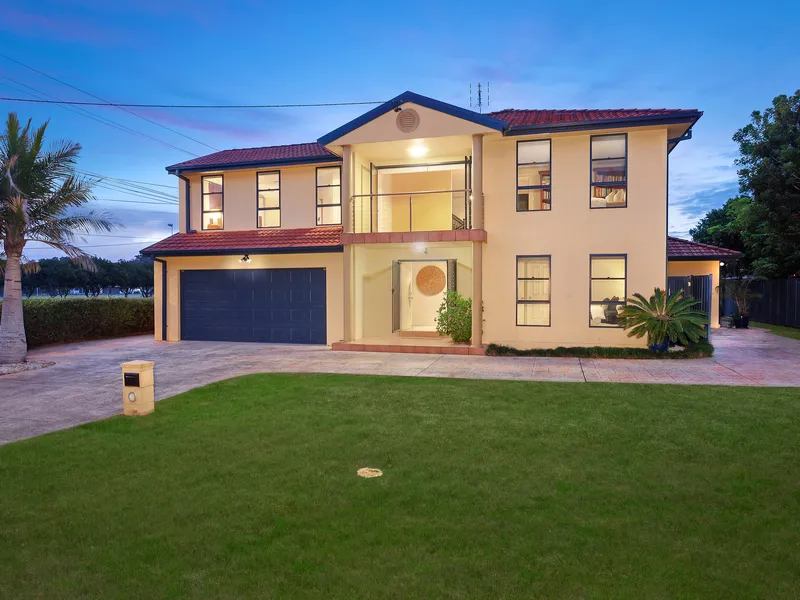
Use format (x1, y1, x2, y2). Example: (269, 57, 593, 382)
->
(483, 128, 667, 348)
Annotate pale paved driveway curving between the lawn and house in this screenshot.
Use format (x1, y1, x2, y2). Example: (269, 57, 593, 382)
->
(0, 329, 800, 444)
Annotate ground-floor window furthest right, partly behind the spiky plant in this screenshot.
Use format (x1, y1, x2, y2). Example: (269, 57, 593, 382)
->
(589, 254, 628, 327)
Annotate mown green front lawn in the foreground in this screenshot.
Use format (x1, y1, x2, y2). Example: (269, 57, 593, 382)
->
(0, 375, 800, 600)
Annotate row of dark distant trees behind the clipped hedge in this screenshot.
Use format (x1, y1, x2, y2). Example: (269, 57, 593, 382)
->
(22, 255, 153, 298)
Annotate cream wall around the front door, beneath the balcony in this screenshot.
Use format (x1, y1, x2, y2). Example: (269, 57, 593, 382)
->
(353, 242, 472, 339)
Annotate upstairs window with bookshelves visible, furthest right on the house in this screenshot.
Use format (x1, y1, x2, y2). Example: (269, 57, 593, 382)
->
(590, 133, 628, 208)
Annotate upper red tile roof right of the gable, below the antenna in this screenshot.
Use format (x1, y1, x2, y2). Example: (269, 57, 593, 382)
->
(488, 108, 699, 128)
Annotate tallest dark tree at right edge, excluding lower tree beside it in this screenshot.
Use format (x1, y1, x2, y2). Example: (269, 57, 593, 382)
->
(733, 90, 800, 278)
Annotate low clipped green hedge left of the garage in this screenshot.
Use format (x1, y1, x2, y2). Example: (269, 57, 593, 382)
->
(0, 298, 155, 348)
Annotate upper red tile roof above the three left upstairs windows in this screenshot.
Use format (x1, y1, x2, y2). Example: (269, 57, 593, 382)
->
(167, 142, 341, 171)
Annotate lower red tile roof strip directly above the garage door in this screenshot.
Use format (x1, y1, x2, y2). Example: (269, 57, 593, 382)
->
(142, 226, 342, 256)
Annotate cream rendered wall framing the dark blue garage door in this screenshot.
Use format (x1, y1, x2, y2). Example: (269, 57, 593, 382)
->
(153, 252, 344, 344)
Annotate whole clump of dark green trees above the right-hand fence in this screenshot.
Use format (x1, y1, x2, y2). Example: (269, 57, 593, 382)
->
(690, 90, 800, 279)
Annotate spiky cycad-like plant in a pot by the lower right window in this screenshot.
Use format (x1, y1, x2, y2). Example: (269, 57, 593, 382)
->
(619, 288, 708, 352)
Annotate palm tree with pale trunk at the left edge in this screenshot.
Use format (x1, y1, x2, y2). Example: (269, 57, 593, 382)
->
(0, 113, 114, 364)
